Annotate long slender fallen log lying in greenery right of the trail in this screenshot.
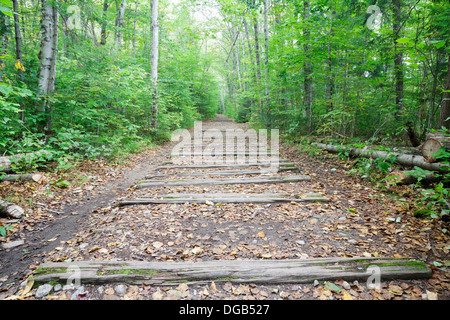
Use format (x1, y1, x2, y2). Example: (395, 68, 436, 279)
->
(312, 142, 449, 172)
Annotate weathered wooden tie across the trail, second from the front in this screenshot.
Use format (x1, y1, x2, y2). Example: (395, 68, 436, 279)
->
(119, 193, 329, 206)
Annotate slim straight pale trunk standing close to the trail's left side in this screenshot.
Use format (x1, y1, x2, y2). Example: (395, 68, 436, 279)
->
(151, 0, 159, 129)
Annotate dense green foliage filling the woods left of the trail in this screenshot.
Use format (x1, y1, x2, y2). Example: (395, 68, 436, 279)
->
(0, 1, 219, 171)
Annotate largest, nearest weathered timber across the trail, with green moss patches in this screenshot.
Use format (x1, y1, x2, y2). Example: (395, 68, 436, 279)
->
(32, 257, 431, 285)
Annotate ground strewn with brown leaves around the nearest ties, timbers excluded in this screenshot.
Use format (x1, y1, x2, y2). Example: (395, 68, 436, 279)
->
(0, 116, 450, 300)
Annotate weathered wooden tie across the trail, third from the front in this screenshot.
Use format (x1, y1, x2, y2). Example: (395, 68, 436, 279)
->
(136, 175, 311, 189)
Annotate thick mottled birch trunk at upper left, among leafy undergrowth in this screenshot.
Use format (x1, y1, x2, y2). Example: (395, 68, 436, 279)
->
(38, 0, 59, 135)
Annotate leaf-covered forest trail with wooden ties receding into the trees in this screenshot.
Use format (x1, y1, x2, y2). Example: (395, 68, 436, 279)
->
(1, 115, 448, 299)
